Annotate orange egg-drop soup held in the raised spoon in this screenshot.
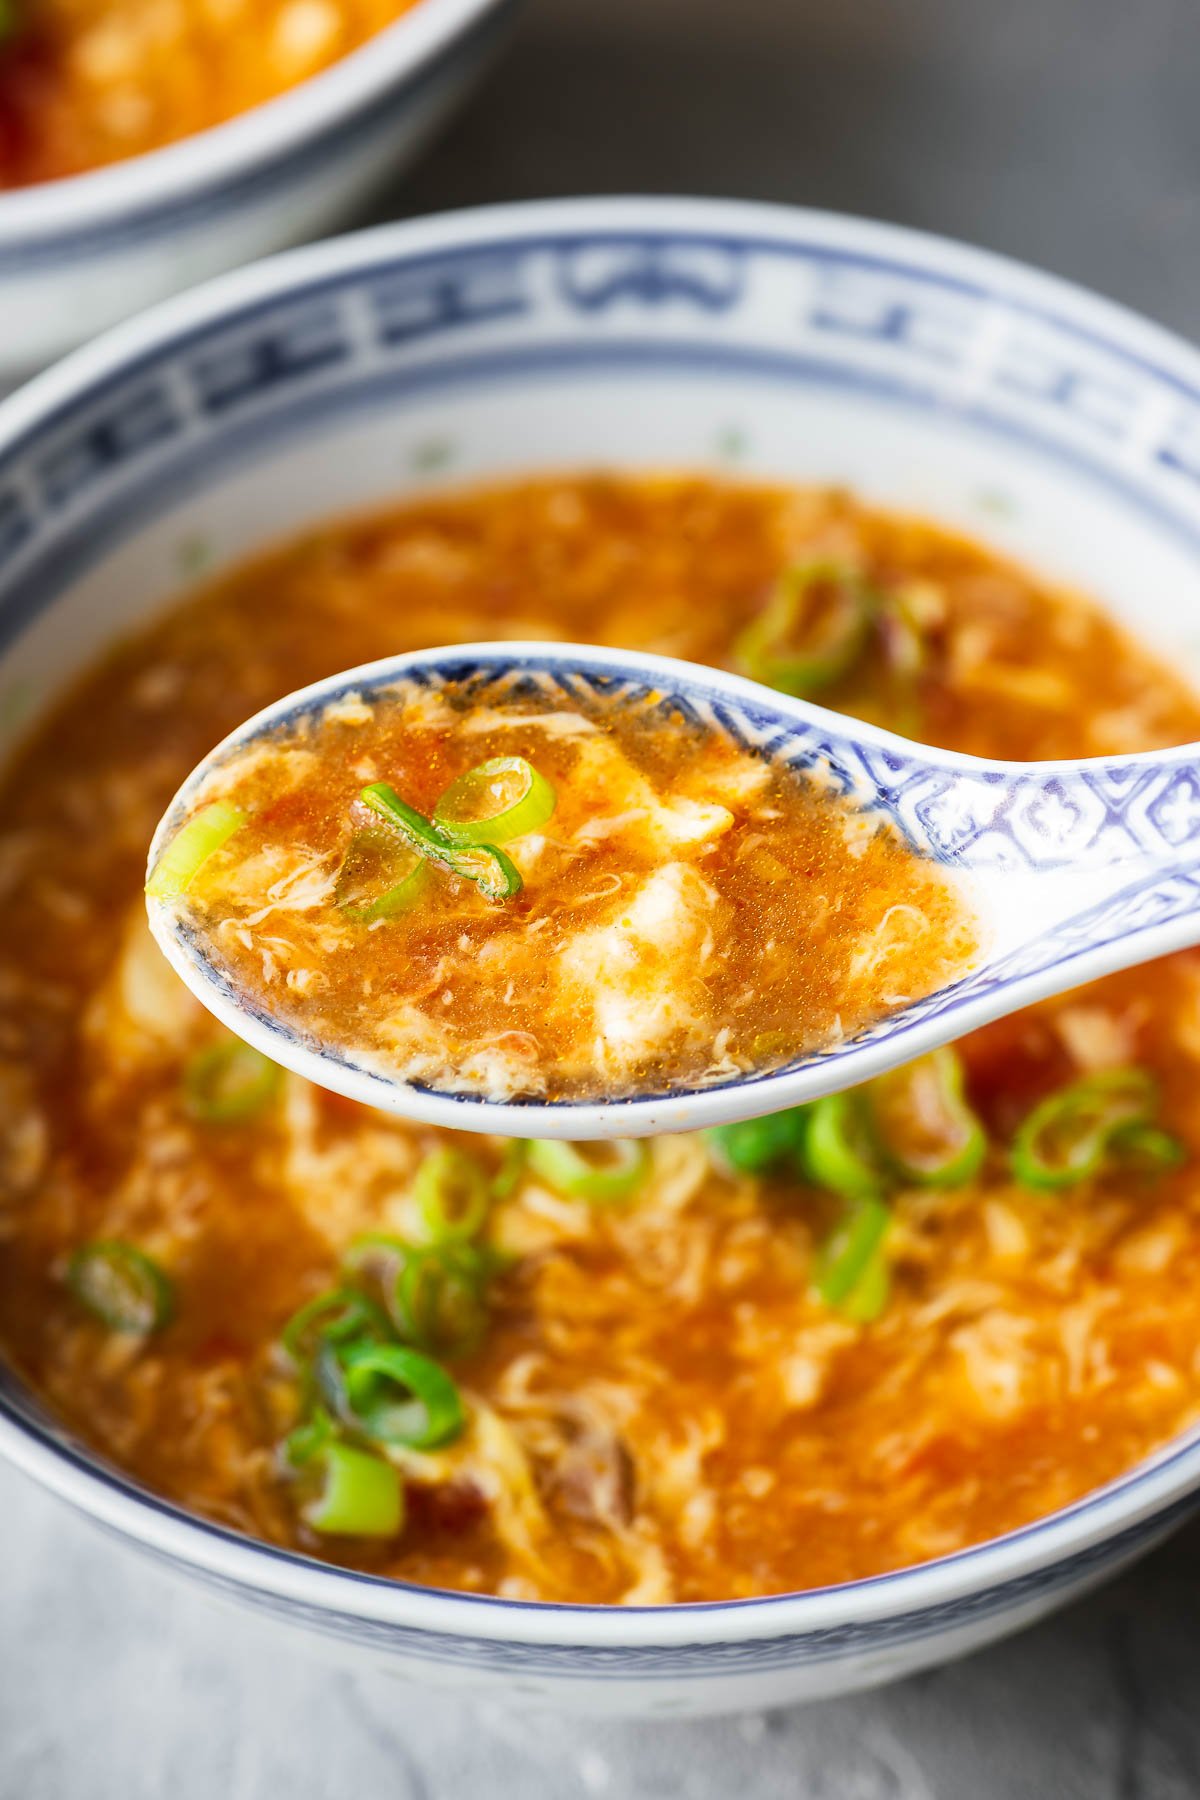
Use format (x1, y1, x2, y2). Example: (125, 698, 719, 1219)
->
(159, 682, 973, 1100)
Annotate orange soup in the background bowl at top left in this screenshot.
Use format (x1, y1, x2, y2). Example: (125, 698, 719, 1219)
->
(0, 0, 416, 189)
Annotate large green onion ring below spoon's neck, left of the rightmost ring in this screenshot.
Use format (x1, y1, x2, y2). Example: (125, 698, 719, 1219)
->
(865, 1049, 988, 1188)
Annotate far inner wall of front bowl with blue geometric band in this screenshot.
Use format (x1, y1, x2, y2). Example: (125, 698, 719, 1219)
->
(0, 202, 1200, 1634)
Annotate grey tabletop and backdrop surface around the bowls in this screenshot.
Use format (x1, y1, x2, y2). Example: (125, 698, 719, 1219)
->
(0, 0, 1200, 1800)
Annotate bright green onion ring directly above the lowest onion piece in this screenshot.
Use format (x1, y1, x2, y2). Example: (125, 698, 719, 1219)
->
(317, 1341, 466, 1451)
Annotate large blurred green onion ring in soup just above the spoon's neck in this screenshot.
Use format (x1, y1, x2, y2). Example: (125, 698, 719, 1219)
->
(734, 560, 878, 697)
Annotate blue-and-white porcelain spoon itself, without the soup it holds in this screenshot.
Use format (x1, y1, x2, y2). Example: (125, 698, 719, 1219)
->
(148, 643, 1200, 1141)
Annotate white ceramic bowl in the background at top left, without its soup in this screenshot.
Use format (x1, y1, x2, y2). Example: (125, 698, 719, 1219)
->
(0, 0, 516, 392)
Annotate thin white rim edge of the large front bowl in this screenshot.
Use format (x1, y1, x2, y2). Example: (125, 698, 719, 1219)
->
(0, 193, 1200, 1649)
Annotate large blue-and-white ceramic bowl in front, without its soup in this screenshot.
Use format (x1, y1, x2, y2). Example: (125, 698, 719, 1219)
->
(0, 200, 1200, 1714)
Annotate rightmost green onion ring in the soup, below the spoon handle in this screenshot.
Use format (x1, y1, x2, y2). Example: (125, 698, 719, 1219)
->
(1009, 1069, 1159, 1192)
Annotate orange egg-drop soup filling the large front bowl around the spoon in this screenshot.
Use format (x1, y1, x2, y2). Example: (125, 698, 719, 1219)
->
(0, 479, 1200, 1602)
